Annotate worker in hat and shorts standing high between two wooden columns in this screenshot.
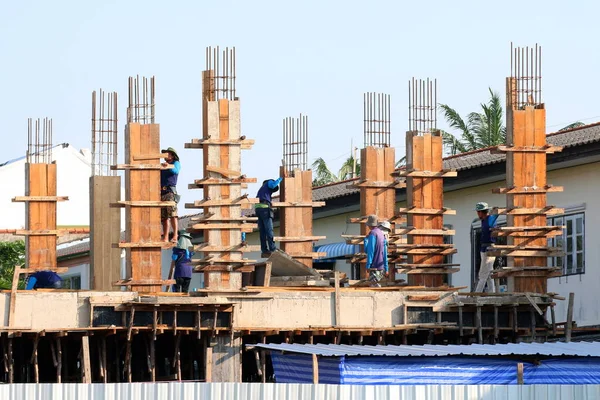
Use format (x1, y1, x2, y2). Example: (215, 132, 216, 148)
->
(160, 147, 181, 243)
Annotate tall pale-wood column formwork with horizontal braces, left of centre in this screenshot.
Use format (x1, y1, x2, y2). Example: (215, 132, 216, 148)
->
(185, 71, 257, 289)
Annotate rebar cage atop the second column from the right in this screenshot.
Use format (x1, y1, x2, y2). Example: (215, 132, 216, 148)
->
(408, 78, 437, 135)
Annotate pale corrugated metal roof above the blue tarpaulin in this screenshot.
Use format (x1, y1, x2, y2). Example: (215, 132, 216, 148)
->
(248, 342, 600, 357)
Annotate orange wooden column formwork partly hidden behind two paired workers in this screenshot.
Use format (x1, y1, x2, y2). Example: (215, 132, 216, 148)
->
(342, 146, 405, 279)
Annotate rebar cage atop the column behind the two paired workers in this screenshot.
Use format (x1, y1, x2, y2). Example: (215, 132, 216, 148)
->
(363, 93, 391, 147)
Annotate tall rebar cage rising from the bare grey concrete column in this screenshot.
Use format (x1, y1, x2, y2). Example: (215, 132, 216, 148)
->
(92, 89, 118, 176)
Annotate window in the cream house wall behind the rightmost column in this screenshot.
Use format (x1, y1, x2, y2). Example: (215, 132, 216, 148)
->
(548, 213, 585, 275)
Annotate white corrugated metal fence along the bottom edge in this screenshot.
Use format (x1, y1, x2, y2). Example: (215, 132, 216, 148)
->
(0, 383, 600, 400)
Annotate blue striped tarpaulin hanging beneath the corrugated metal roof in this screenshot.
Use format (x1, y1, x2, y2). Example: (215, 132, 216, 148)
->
(272, 352, 600, 385)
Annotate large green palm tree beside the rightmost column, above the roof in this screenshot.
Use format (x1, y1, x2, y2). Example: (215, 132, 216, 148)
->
(440, 88, 506, 155)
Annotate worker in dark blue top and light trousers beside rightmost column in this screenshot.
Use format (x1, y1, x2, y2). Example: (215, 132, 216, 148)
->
(475, 202, 498, 292)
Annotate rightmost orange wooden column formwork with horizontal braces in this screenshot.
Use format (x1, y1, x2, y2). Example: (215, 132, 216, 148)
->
(491, 78, 564, 293)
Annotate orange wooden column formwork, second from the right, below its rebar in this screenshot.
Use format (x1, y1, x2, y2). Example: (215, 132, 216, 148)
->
(394, 131, 458, 287)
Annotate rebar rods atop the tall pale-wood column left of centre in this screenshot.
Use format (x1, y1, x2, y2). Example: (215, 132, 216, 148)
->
(206, 46, 236, 100)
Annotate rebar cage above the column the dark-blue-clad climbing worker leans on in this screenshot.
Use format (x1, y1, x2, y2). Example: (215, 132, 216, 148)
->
(283, 114, 308, 174)
